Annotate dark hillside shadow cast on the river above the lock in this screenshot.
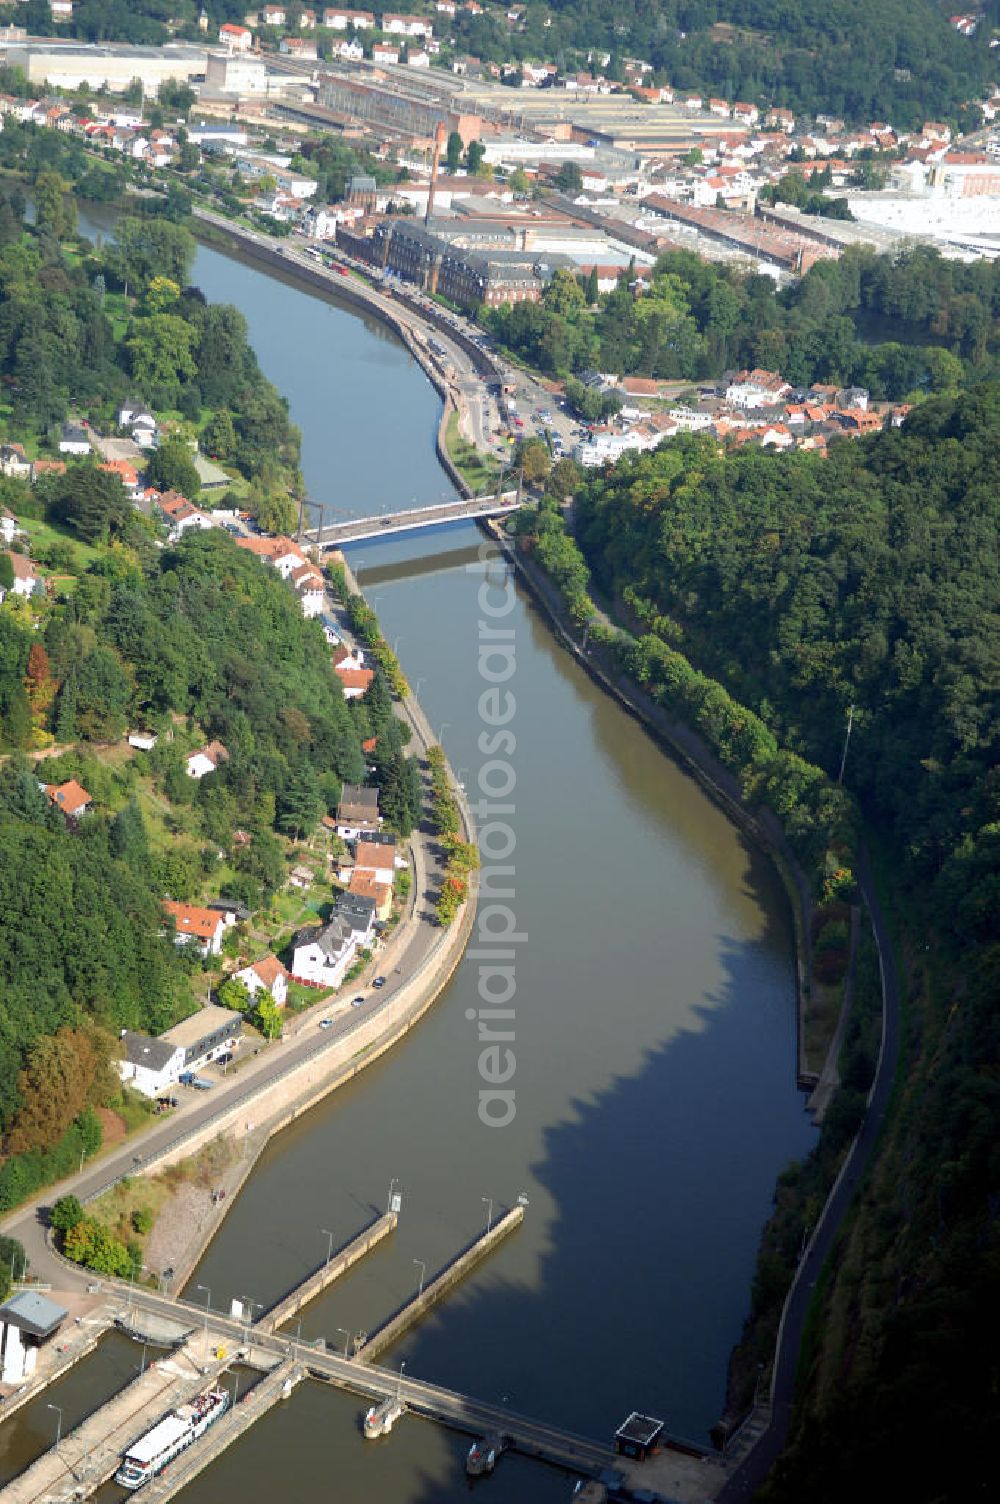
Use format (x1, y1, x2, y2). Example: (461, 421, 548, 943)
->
(383, 902, 812, 1479)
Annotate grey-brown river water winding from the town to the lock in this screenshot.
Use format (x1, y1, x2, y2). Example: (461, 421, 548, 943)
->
(42, 206, 812, 1504)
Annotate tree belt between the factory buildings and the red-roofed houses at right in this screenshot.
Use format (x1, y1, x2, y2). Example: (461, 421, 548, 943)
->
(483, 247, 1000, 400)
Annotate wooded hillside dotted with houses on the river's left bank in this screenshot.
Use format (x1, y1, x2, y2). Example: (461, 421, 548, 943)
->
(0, 191, 420, 1209)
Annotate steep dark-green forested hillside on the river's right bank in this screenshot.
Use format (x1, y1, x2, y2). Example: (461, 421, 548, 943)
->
(576, 385, 1000, 1504)
